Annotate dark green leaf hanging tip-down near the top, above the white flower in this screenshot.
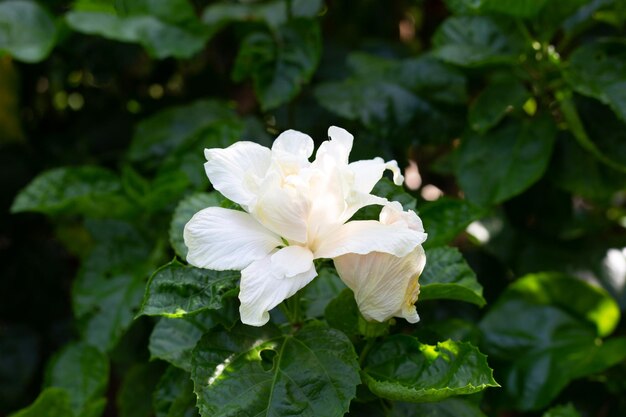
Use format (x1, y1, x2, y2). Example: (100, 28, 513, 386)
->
(232, 19, 322, 111)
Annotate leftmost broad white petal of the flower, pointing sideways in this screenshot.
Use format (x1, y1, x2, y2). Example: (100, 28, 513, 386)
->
(183, 207, 282, 271)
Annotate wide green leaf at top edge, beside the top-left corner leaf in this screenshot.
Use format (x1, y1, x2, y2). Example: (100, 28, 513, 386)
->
(65, 0, 208, 59)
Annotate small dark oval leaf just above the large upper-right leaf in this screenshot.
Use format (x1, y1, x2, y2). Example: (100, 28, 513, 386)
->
(468, 79, 530, 133)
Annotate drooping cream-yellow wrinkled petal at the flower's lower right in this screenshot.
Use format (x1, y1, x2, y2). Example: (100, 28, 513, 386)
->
(334, 246, 426, 323)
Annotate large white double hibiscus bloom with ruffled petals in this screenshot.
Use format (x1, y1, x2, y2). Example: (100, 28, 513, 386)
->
(184, 127, 426, 326)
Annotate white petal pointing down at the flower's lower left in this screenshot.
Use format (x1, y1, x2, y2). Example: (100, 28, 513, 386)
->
(239, 250, 317, 326)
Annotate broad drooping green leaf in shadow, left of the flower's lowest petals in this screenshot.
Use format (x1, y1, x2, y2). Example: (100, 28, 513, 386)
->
(72, 220, 154, 351)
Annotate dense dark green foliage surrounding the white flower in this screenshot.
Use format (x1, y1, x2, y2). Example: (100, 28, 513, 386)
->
(0, 0, 626, 417)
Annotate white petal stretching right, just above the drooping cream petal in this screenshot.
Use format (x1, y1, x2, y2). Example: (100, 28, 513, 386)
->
(314, 220, 426, 258)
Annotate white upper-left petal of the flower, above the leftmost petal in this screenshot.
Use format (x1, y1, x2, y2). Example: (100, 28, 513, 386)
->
(204, 141, 271, 208)
